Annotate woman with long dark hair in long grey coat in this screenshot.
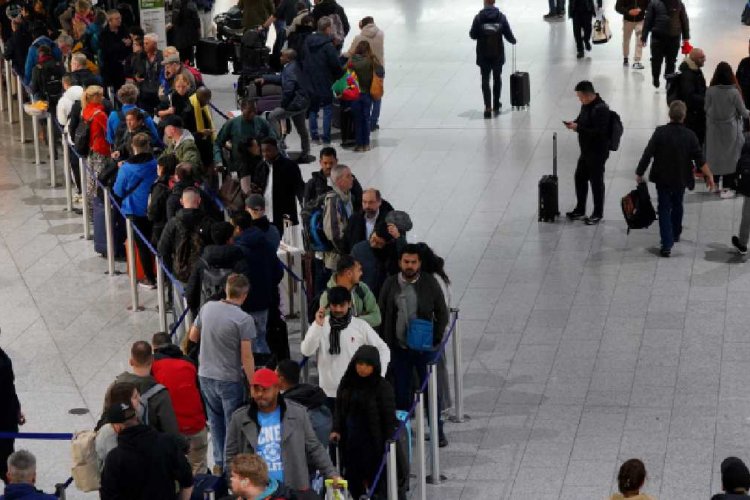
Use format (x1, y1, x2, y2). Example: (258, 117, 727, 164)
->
(705, 61, 750, 198)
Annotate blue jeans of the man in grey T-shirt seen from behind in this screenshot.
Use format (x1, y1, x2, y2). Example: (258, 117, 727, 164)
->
(200, 377, 245, 467)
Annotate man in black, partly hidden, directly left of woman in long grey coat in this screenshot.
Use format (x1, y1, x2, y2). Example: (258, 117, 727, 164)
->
(677, 48, 706, 146)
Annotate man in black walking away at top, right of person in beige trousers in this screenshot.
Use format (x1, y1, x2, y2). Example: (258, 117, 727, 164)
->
(641, 0, 690, 88)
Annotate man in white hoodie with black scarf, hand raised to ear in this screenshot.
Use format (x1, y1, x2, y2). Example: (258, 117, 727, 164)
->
(300, 283, 390, 411)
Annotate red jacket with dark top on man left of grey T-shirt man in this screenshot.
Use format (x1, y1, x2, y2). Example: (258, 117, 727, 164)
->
(151, 344, 206, 436)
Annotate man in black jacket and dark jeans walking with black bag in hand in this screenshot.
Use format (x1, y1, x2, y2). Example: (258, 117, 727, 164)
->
(635, 100, 714, 257)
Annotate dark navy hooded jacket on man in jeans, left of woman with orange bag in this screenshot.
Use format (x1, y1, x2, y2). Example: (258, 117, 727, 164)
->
(302, 31, 344, 105)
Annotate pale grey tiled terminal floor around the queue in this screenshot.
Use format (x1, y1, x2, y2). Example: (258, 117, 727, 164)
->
(0, 0, 750, 500)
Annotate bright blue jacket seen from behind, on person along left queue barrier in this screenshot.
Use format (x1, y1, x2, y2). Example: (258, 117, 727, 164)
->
(114, 153, 157, 217)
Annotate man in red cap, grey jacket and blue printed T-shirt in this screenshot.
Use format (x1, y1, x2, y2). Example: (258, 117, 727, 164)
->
(225, 368, 339, 490)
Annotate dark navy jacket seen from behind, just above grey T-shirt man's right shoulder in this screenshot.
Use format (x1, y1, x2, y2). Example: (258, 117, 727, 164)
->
(234, 227, 284, 313)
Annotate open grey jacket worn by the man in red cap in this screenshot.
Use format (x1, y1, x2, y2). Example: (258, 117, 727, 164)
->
(225, 394, 338, 490)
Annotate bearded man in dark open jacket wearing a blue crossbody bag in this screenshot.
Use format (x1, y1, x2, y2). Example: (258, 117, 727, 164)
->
(378, 244, 449, 447)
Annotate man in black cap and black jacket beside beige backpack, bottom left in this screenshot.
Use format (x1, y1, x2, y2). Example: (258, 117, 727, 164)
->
(99, 403, 193, 500)
